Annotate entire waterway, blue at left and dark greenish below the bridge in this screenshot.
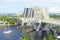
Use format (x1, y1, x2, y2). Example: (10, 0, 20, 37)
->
(0, 26, 57, 40)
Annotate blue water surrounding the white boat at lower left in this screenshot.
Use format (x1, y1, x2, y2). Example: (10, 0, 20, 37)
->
(0, 26, 22, 40)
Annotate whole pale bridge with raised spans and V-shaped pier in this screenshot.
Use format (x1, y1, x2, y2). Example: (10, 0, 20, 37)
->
(18, 7, 60, 31)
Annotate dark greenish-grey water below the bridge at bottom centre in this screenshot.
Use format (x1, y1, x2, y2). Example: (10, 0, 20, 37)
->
(27, 31, 47, 40)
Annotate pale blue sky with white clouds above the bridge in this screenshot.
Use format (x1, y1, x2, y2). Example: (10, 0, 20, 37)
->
(0, 0, 60, 13)
